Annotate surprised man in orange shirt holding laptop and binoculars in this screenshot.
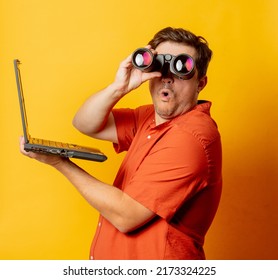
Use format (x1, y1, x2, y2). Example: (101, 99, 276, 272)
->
(21, 27, 222, 259)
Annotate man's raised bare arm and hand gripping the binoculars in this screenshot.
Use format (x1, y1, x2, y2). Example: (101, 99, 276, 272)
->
(73, 51, 161, 141)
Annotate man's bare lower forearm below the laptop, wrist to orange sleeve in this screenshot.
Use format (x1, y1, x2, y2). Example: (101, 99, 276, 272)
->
(54, 160, 154, 232)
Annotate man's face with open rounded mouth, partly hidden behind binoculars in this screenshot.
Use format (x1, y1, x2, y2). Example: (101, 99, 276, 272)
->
(149, 42, 207, 125)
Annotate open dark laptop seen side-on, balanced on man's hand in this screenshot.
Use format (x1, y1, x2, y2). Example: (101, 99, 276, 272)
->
(14, 59, 107, 162)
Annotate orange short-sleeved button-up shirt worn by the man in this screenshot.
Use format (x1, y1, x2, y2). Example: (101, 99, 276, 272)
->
(91, 101, 222, 260)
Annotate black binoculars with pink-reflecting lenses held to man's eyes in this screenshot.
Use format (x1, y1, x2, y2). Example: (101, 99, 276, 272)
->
(132, 48, 195, 80)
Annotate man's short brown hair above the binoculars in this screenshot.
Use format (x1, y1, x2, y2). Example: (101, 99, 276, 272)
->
(148, 27, 212, 79)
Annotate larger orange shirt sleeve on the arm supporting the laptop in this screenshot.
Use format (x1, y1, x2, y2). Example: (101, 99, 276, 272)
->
(124, 129, 208, 221)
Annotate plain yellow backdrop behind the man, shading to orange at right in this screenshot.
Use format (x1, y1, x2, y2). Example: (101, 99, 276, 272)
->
(0, 0, 278, 259)
